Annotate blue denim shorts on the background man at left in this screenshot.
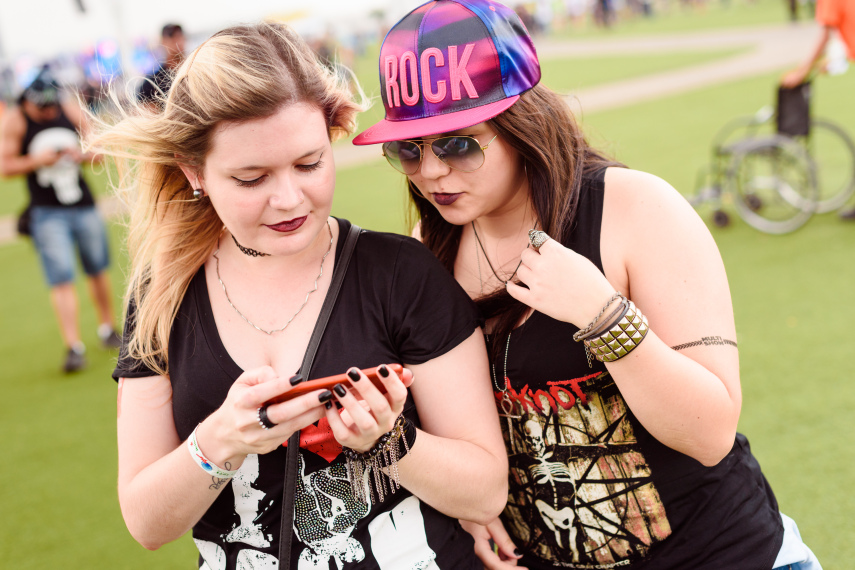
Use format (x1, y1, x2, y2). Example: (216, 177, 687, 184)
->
(31, 206, 110, 287)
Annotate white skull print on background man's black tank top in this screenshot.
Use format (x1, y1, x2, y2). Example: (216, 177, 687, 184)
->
(27, 127, 83, 206)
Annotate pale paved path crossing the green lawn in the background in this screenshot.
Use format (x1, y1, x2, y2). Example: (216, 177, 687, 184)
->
(0, 19, 819, 244)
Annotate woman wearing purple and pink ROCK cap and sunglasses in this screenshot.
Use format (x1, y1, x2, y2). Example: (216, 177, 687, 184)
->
(354, 0, 819, 570)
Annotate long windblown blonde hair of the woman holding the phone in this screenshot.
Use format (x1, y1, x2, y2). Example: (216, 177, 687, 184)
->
(89, 23, 365, 374)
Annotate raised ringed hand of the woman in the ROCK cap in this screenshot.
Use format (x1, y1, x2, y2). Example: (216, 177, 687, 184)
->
(507, 235, 615, 328)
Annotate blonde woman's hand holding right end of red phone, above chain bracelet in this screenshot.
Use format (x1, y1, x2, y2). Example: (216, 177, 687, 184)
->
(326, 366, 413, 453)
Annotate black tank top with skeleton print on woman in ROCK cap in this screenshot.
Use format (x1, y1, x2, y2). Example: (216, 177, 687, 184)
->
(493, 170, 783, 570)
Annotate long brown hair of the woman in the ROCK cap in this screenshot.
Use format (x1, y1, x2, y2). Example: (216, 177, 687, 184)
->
(408, 85, 623, 360)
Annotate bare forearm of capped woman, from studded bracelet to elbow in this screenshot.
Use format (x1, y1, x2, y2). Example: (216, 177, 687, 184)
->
(606, 330, 741, 466)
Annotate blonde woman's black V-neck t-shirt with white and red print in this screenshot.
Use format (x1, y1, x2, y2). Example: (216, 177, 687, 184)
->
(113, 220, 481, 570)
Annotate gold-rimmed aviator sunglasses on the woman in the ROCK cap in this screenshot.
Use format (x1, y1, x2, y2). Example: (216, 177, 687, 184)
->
(383, 135, 499, 176)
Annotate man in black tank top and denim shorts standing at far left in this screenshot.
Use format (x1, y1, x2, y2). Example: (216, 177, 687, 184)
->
(0, 67, 121, 372)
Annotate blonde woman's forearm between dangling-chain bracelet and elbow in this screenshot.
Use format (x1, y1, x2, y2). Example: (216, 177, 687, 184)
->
(398, 430, 508, 524)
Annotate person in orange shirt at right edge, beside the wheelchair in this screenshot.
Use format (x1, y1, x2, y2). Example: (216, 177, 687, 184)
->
(781, 0, 855, 217)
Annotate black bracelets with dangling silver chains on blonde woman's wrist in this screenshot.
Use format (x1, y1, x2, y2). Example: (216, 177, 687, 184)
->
(343, 415, 417, 502)
